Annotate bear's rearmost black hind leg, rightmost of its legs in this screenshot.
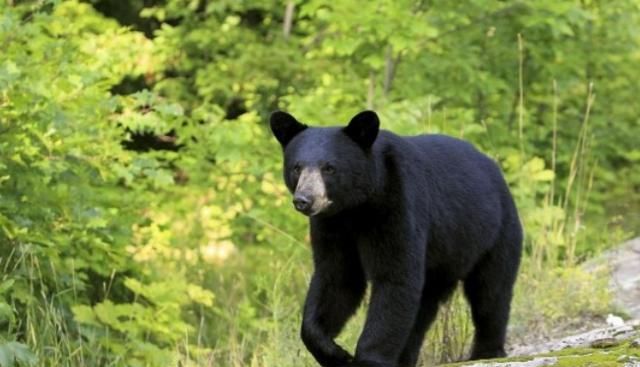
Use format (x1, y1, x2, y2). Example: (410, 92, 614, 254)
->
(464, 231, 522, 360)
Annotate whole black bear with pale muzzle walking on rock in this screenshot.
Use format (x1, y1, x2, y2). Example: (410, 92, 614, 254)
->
(270, 111, 522, 367)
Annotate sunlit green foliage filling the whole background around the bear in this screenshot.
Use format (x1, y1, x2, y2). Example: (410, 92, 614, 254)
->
(0, 0, 640, 367)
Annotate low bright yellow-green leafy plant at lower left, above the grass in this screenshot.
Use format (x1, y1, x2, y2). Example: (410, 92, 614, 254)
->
(73, 277, 213, 366)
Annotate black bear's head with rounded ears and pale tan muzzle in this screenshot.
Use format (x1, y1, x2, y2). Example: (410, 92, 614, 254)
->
(271, 111, 380, 216)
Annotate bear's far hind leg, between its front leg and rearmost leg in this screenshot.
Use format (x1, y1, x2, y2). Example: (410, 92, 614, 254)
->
(398, 274, 457, 367)
